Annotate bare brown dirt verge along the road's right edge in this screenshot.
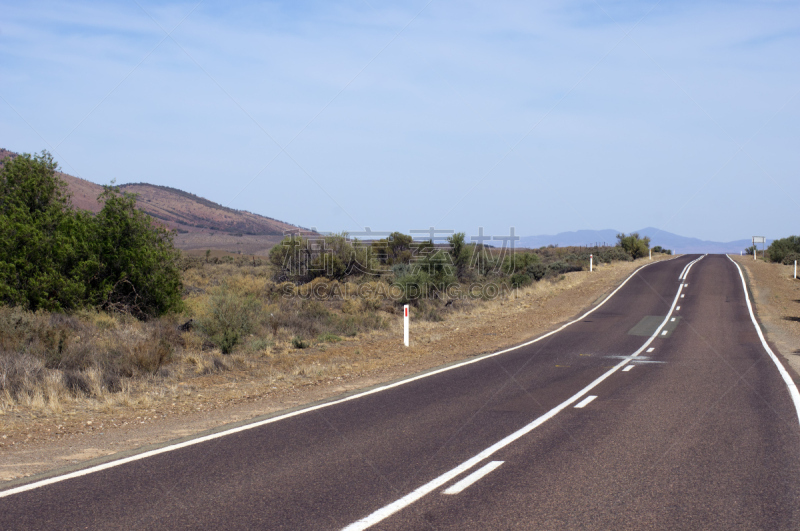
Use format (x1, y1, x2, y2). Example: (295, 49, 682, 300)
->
(732, 256, 800, 374)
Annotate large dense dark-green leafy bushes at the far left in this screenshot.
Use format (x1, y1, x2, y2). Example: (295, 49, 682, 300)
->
(0, 151, 182, 319)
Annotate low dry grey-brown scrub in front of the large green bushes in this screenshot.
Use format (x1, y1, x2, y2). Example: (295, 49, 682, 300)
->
(0, 307, 183, 407)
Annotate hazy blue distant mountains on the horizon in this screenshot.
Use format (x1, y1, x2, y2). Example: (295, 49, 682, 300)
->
(517, 227, 772, 254)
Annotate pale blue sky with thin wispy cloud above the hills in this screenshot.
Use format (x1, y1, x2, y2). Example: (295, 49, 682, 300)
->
(0, 0, 800, 241)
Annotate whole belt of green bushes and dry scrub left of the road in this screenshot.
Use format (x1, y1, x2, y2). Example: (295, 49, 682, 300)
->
(0, 153, 668, 412)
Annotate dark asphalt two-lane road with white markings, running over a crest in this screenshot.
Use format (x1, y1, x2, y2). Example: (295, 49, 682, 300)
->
(0, 255, 800, 530)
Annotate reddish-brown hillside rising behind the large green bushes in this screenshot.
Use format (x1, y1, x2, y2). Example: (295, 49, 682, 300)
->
(0, 148, 306, 236)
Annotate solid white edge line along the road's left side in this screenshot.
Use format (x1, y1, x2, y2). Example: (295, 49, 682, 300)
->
(0, 256, 679, 498)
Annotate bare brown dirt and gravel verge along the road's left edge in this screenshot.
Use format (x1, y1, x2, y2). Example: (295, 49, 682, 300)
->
(0, 256, 668, 484)
